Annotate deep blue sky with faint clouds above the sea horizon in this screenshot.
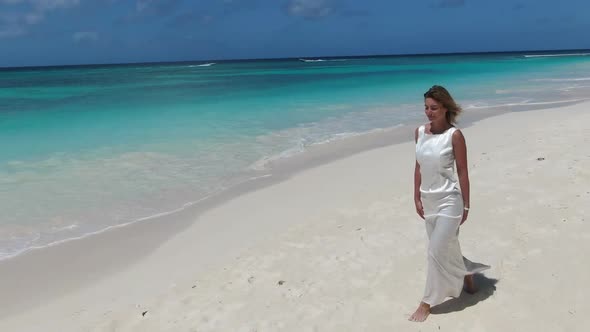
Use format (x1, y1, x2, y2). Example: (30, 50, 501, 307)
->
(0, 0, 590, 67)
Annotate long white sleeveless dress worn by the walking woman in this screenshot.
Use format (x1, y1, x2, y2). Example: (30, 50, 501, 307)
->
(416, 125, 489, 306)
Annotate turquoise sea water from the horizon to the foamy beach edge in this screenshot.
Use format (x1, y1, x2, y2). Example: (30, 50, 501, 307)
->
(0, 52, 590, 258)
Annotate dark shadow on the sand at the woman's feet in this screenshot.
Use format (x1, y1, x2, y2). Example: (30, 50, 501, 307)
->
(430, 273, 498, 315)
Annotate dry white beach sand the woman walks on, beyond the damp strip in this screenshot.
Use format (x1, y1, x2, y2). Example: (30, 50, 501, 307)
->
(0, 103, 590, 332)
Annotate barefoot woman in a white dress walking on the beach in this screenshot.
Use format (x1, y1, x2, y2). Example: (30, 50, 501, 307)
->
(409, 85, 489, 322)
